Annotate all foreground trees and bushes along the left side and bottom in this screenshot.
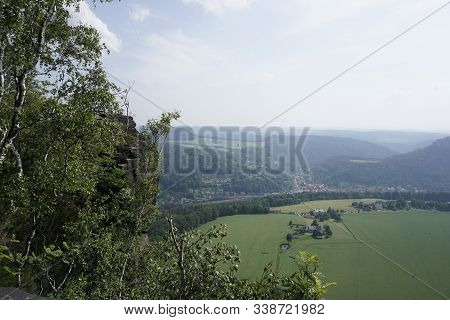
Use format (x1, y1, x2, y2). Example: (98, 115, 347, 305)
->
(0, 0, 327, 299)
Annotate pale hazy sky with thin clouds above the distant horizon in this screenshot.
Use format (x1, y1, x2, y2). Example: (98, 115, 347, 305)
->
(74, 0, 450, 132)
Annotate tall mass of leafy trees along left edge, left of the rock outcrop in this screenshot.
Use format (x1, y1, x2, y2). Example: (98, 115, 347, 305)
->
(0, 0, 131, 294)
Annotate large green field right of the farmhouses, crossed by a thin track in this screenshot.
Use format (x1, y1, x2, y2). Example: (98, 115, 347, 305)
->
(310, 211, 450, 299)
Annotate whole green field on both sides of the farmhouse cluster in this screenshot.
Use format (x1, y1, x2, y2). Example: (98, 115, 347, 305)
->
(201, 206, 450, 299)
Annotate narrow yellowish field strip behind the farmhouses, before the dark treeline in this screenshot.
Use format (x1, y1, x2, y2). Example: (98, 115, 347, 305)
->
(272, 199, 377, 213)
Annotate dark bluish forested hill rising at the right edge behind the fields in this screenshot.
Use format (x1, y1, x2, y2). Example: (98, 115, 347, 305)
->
(314, 137, 450, 191)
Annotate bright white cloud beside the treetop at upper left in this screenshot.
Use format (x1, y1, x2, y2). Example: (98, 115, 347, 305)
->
(69, 1, 122, 52)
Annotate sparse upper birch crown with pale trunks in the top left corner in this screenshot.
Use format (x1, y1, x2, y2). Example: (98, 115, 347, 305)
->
(0, 0, 118, 177)
